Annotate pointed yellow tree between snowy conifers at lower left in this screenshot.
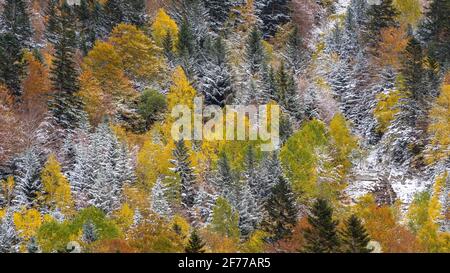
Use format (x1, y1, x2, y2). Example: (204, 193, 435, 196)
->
(41, 154, 73, 214)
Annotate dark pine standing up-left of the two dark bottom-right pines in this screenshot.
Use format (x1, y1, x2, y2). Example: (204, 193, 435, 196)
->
(263, 176, 298, 242)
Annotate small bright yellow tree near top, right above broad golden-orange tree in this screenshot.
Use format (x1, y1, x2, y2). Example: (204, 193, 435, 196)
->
(152, 8, 178, 50)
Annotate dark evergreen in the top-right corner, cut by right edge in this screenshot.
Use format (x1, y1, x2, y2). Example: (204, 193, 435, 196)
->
(420, 0, 450, 66)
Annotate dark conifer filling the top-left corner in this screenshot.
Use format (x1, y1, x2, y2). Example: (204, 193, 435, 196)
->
(1, 0, 33, 48)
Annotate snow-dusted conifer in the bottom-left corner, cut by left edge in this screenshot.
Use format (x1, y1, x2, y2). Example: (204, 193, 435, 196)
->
(0, 210, 20, 253)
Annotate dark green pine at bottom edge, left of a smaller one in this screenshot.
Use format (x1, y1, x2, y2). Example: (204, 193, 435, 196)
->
(304, 199, 341, 253)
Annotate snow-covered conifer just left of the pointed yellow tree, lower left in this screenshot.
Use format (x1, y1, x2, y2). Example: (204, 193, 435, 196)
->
(12, 148, 42, 208)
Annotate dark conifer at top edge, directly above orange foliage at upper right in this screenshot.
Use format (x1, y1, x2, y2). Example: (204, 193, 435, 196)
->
(367, 0, 399, 44)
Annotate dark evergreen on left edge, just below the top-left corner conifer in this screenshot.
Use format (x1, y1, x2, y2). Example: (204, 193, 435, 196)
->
(0, 32, 25, 99)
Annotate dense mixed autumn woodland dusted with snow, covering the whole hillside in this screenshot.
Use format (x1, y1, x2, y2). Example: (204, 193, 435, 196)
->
(0, 0, 450, 253)
